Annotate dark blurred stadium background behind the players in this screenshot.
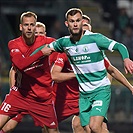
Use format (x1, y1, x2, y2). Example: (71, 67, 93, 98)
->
(0, 0, 133, 133)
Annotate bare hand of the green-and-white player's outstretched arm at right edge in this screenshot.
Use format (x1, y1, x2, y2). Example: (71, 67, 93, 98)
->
(124, 58, 133, 74)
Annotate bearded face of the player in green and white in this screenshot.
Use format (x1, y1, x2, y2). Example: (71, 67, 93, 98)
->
(66, 13, 82, 35)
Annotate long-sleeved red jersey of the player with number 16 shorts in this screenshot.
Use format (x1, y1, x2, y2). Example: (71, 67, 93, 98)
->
(8, 36, 55, 100)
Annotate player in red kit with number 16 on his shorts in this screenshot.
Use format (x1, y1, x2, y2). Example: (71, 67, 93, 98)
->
(0, 12, 57, 133)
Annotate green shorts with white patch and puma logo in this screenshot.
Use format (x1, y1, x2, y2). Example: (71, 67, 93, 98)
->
(79, 86, 111, 126)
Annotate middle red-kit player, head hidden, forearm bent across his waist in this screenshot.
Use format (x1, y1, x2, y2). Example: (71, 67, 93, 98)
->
(50, 53, 79, 122)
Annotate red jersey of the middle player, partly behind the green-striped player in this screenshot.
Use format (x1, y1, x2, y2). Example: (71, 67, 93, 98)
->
(53, 53, 79, 100)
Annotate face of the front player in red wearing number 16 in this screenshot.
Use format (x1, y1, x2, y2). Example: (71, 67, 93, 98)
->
(20, 16, 36, 39)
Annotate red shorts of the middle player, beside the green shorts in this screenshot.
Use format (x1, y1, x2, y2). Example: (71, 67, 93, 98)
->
(55, 100, 79, 122)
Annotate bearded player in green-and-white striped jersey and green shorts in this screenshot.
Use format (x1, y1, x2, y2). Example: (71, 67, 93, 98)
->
(49, 8, 133, 133)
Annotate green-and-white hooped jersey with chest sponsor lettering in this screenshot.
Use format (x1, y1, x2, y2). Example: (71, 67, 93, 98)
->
(49, 31, 128, 93)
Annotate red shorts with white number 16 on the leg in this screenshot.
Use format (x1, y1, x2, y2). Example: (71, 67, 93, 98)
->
(0, 90, 57, 128)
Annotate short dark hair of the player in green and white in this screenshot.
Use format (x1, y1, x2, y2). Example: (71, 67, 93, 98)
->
(65, 8, 83, 20)
